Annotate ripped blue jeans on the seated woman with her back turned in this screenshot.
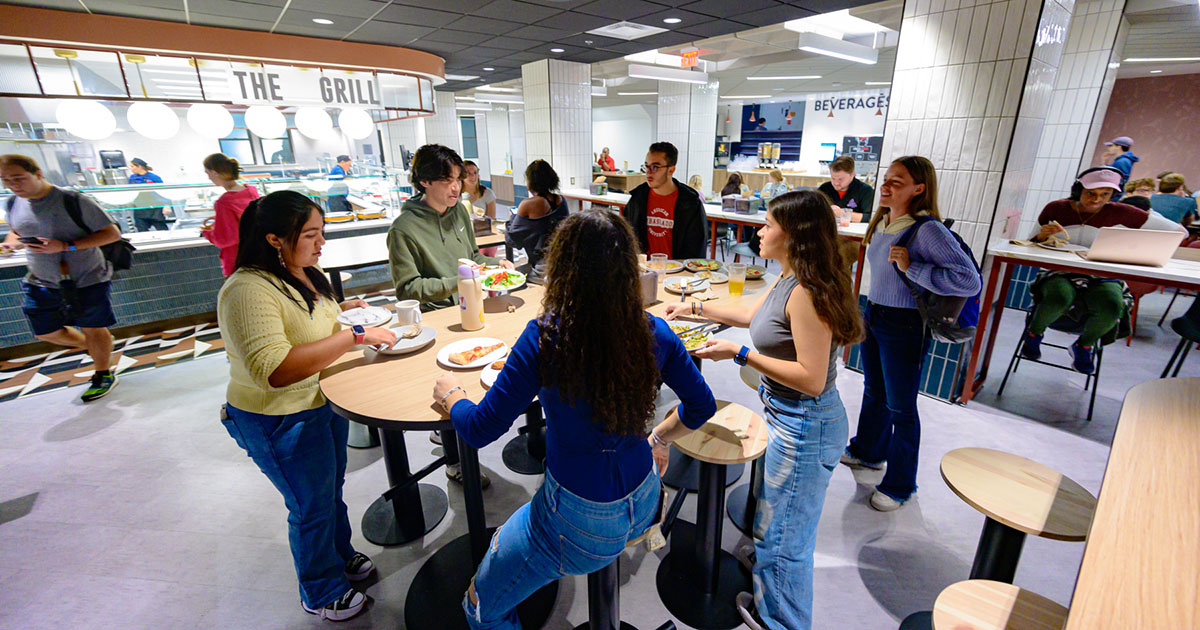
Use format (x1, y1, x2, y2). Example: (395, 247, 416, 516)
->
(462, 468, 661, 630)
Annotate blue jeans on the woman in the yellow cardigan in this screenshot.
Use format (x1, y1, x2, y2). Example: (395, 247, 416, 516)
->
(221, 403, 354, 608)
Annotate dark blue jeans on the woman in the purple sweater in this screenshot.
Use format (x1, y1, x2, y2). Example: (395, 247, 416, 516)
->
(846, 304, 929, 502)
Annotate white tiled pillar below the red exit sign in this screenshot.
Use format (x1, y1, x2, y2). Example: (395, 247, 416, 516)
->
(662, 80, 720, 187)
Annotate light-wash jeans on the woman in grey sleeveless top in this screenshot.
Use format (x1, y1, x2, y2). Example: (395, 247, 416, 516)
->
(754, 386, 850, 630)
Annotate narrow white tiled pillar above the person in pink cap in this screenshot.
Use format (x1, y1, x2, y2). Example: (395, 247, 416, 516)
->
(1012, 0, 1127, 238)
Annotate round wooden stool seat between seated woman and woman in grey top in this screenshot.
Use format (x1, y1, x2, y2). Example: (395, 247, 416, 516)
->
(674, 401, 767, 464)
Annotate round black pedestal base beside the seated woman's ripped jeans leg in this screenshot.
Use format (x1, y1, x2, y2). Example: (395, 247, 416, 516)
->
(404, 527, 558, 630)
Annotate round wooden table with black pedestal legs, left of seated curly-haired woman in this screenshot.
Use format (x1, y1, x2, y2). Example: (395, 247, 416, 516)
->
(320, 286, 558, 630)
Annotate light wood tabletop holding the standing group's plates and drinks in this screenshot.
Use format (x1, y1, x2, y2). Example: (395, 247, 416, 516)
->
(320, 268, 770, 430)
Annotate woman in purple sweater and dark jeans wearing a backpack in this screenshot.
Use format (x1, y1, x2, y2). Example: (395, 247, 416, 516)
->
(841, 156, 982, 511)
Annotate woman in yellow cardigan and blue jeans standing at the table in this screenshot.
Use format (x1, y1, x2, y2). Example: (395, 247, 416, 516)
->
(217, 191, 396, 622)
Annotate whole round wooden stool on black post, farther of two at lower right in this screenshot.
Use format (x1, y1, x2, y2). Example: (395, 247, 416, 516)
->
(941, 448, 1096, 583)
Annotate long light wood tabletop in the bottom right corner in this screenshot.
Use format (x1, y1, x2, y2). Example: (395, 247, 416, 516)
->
(1067, 378, 1200, 630)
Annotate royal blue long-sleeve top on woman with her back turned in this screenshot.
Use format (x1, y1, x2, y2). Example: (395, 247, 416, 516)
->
(450, 316, 716, 502)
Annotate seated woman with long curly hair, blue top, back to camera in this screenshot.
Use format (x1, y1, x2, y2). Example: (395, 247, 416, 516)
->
(433, 211, 716, 630)
